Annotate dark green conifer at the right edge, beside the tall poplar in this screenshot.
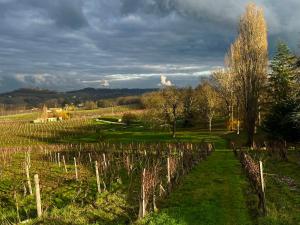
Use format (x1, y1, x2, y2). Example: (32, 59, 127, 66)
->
(263, 42, 300, 141)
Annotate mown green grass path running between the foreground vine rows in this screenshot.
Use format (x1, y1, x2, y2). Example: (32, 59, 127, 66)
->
(145, 151, 253, 225)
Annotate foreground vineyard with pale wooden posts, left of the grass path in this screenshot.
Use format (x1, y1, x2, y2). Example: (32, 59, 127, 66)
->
(0, 143, 213, 223)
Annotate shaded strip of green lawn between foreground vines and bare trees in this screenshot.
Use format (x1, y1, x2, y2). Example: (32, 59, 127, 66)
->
(23, 123, 227, 149)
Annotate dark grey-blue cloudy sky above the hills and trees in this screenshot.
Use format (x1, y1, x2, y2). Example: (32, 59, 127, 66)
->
(0, 0, 300, 92)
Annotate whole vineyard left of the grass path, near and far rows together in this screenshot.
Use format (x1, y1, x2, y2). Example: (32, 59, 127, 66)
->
(0, 111, 213, 224)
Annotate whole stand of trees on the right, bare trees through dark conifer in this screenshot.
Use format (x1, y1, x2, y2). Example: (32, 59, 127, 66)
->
(142, 3, 300, 146)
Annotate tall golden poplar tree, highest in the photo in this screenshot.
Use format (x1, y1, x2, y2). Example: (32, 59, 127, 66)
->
(228, 3, 268, 146)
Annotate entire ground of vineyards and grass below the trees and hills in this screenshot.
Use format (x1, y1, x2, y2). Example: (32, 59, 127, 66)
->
(0, 107, 300, 225)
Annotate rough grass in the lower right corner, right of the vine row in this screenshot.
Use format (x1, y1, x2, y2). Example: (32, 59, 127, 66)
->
(252, 151, 300, 225)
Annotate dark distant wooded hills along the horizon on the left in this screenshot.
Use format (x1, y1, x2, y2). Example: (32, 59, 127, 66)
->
(0, 88, 156, 107)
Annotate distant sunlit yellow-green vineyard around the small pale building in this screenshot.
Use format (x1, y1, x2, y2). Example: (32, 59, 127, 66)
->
(0, 106, 134, 146)
